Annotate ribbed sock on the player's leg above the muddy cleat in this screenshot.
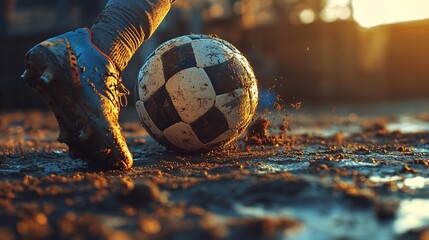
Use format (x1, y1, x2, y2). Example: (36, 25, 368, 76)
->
(91, 0, 174, 71)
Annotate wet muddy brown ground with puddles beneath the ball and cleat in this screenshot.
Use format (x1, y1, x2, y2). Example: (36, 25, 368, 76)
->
(0, 107, 429, 239)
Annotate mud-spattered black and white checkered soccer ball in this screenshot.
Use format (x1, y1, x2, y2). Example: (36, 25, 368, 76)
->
(135, 35, 258, 153)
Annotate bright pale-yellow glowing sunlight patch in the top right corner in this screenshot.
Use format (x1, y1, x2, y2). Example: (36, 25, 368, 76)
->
(352, 0, 429, 28)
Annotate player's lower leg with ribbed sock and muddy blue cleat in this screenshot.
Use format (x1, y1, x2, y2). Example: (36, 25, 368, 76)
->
(22, 0, 170, 169)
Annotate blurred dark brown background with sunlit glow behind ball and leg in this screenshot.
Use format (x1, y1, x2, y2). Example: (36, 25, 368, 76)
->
(0, 0, 429, 110)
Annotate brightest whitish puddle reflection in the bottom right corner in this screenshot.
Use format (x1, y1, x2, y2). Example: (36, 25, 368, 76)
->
(394, 199, 429, 234)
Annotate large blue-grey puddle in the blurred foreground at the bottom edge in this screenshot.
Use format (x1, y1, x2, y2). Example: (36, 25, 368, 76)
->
(235, 203, 393, 240)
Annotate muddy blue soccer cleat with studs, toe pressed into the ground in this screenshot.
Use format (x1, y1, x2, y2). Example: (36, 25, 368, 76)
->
(21, 28, 133, 169)
